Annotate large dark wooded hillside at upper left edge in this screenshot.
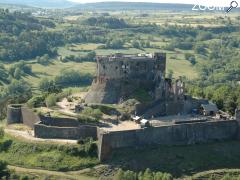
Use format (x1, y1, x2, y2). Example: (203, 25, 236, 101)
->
(0, 10, 63, 62)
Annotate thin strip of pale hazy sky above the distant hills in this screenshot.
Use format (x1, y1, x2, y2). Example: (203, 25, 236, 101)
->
(69, 0, 232, 7)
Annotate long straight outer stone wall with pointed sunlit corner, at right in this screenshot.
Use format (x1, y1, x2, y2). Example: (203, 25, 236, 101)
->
(98, 120, 238, 160)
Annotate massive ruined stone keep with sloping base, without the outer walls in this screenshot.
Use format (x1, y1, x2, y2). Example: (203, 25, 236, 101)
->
(85, 53, 184, 104)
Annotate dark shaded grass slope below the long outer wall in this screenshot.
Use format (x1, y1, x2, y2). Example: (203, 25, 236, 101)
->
(109, 141, 240, 177)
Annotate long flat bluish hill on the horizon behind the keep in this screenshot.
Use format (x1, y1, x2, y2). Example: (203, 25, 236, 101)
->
(73, 2, 193, 11)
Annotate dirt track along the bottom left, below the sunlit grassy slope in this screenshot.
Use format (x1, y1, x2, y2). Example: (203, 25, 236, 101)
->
(8, 165, 97, 180)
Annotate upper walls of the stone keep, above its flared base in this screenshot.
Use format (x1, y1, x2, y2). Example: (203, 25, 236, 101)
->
(96, 53, 166, 82)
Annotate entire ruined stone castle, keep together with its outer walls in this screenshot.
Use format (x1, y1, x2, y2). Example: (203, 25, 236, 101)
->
(7, 53, 240, 161)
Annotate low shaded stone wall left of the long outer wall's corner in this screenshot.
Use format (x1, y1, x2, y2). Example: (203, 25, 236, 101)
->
(34, 123, 97, 140)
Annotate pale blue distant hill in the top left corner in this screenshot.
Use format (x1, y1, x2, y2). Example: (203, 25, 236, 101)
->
(0, 0, 76, 8)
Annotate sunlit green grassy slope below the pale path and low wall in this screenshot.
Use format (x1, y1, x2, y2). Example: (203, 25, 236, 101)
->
(0, 136, 99, 171)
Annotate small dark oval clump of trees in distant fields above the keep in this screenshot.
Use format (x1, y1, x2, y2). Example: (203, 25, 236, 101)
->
(84, 16, 129, 29)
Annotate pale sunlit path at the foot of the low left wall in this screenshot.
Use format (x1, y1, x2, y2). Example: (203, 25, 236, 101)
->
(4, 128, 77, 144)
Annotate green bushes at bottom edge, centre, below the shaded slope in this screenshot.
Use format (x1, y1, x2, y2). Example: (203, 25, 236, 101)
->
(114, 169, 173, 180)
